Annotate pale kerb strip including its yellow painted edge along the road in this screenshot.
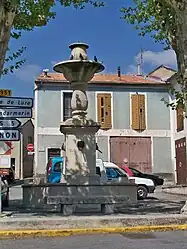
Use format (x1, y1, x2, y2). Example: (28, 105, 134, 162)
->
(0, 214, 187, 239)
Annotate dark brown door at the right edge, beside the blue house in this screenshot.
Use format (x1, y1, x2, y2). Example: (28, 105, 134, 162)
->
(175, 137, 187, 184)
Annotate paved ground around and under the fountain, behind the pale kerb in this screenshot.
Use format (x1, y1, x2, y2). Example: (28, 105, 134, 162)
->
(4, 182, 186, 217)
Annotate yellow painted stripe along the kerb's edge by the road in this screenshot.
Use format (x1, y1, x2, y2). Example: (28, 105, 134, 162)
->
(0, 224, 187, 239)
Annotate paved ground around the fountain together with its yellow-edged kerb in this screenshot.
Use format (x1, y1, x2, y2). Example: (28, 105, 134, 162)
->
(0, 186, 187, 238)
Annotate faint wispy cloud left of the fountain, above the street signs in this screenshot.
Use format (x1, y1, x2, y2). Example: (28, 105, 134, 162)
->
(15, 64, 42, 83)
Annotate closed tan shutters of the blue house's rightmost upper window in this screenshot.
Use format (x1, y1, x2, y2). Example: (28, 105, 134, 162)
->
(131, 94, 146, 131)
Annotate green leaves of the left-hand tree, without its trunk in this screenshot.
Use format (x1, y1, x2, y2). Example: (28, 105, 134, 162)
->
(0, 0, 104, 75)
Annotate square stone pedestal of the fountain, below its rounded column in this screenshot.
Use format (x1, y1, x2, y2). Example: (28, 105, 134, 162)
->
(60, 123, 100, 184)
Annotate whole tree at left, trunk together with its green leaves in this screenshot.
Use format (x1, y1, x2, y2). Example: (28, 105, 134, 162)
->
(0, 0, 103, 76)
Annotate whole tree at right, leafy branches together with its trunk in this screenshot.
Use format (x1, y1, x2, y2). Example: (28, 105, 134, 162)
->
(121, 0, 187, 117)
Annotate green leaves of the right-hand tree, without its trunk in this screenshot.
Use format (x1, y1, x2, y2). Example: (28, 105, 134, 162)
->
(121, 0, 176, 49)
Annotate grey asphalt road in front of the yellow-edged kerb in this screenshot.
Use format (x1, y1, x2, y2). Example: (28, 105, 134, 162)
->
(0, 231, 187, 249)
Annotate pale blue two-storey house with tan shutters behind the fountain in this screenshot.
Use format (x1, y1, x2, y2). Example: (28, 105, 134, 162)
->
(34, 73, 174, 178)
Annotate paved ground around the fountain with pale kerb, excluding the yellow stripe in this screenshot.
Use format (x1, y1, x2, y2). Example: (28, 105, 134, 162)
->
(0, 186, 187, 231)
